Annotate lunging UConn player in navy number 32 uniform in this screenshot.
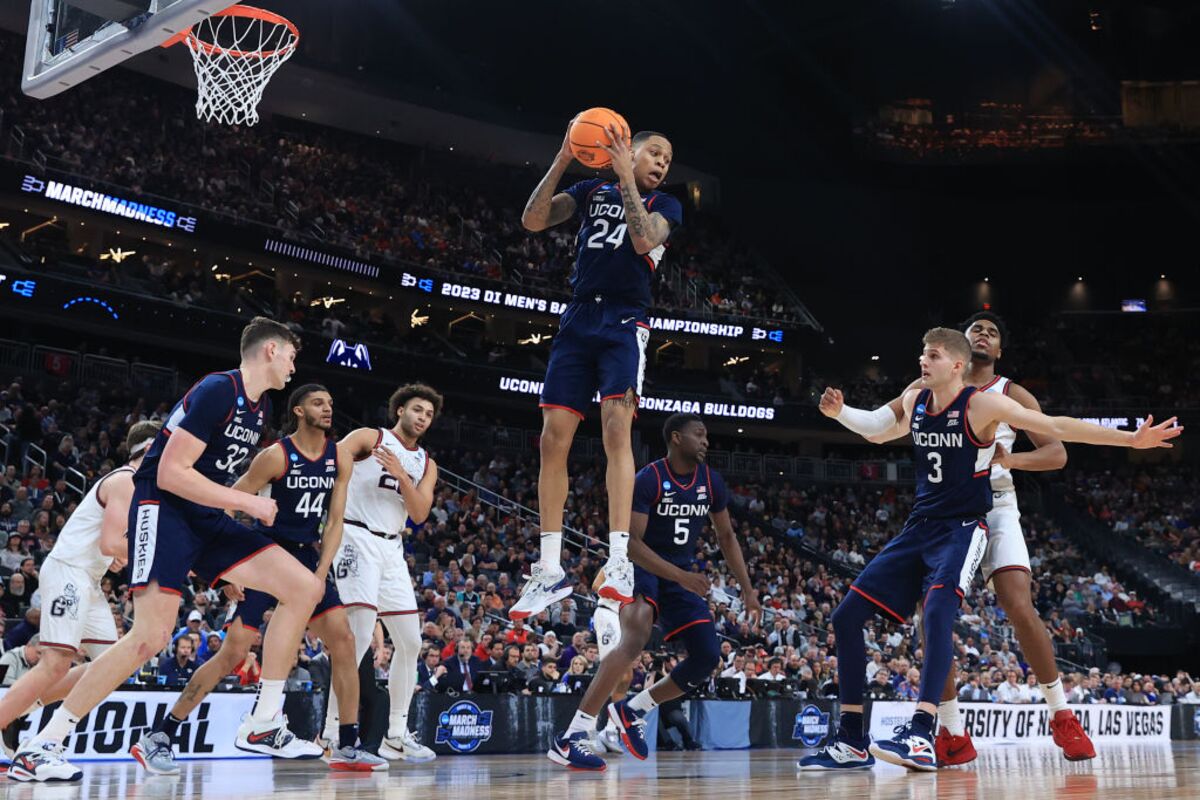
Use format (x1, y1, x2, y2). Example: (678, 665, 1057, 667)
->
(8, 317, 325, 781)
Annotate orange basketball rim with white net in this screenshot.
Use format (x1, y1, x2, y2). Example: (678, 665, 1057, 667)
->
(163, 6, 300, 125)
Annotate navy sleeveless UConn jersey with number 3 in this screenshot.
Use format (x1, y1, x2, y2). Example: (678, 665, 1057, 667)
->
(912, 386, 996, 519)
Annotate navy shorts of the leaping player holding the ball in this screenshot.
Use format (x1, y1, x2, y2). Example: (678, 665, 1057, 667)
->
(540, 296, 650, 420)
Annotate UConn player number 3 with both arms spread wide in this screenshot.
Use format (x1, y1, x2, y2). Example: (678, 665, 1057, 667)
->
(799, 327, 1183, 771)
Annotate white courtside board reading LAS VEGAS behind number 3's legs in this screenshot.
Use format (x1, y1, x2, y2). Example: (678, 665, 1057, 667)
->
(871, 703, 1171, 744)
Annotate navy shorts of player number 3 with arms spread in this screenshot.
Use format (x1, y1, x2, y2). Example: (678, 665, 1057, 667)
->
(851, 517, 988, 622)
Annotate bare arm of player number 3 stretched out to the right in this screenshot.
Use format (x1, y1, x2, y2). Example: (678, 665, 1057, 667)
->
(971, 395, 1183, 450)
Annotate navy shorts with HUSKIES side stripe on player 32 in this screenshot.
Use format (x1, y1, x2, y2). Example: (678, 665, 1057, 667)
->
(128, 480, 275, 595)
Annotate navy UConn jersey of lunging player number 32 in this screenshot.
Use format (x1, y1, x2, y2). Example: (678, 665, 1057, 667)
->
(133, 369, 271, 496)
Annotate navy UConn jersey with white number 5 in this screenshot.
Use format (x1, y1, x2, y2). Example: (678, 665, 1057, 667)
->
(634, 458, 730, 566)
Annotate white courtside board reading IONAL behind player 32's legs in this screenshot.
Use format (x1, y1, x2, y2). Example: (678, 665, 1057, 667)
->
(1, 691, 263, 760)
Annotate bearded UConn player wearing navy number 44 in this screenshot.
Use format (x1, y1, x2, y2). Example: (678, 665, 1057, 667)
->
(131, 384, 388, 775)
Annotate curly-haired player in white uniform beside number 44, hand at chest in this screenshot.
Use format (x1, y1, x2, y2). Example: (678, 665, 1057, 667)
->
(324, 384, 442, 762)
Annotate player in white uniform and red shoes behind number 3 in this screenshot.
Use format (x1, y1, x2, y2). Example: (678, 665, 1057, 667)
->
(883, 311, 1096, 766)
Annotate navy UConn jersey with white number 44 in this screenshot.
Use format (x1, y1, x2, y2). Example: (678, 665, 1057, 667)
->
(254, 437, 337, 545)
